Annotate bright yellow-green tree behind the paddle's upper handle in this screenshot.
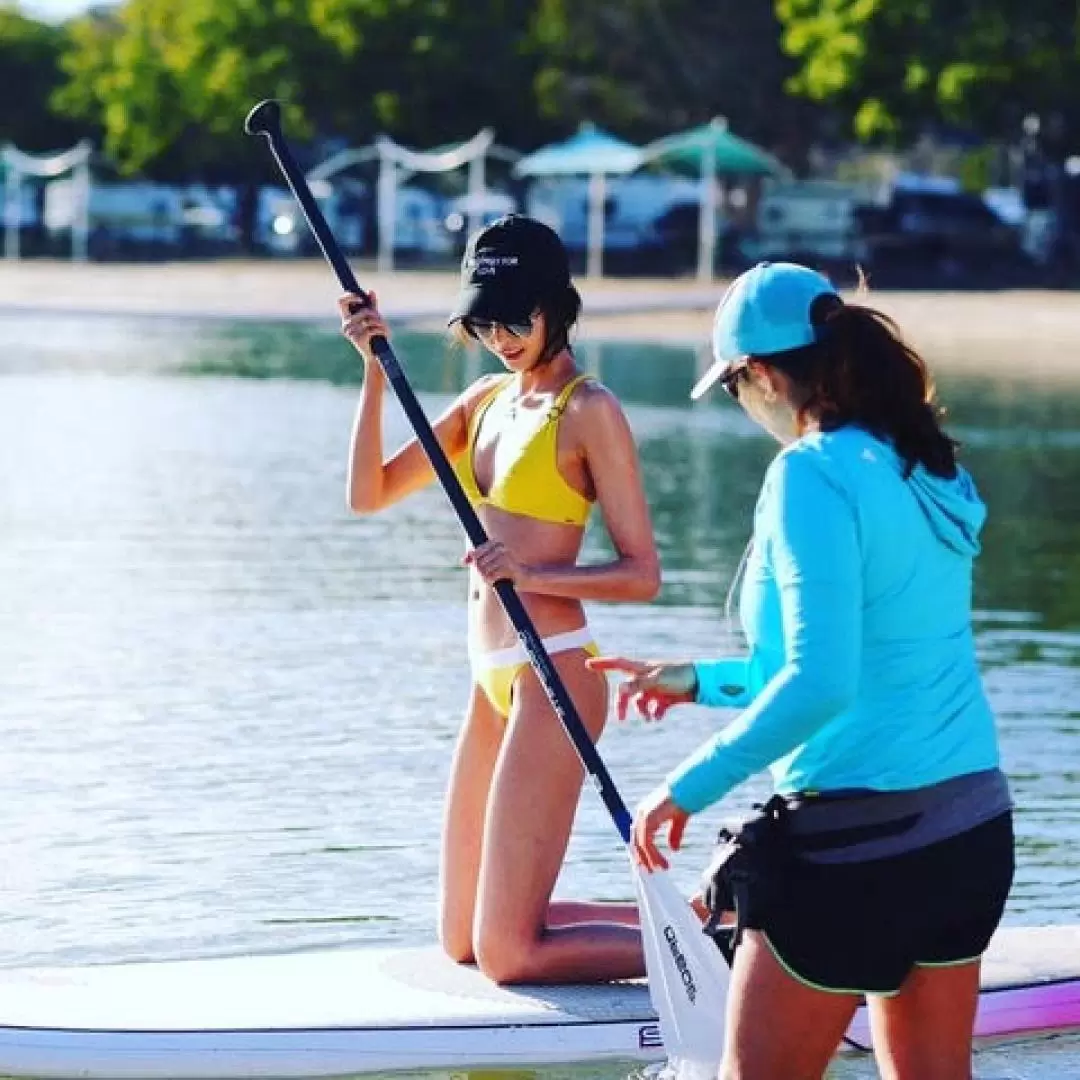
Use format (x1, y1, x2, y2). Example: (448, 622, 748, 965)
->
(56, 0, 348, 178)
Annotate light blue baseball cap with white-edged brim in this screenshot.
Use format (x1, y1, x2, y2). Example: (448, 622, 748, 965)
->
(690, 262, 839, 399)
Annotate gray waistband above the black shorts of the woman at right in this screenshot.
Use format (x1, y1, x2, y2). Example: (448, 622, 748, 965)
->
(786, 769, 1012, 863)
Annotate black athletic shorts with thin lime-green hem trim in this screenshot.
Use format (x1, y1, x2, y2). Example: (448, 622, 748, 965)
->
(744, 812, 1014, 995)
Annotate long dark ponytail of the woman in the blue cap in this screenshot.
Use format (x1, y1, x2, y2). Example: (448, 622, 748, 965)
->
(754, 294, 959, 477)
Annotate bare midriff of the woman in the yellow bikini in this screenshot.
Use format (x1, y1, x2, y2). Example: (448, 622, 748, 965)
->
(469, 507, 585, 652)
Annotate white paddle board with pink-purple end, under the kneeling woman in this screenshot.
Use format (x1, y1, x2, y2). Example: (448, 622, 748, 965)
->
(0, 926, 1080, 1080)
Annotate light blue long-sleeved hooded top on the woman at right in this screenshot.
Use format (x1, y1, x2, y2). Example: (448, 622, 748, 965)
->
(667, 427, 999, 813)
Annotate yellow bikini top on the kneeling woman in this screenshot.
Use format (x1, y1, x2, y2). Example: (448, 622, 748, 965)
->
(454, 375, 593, 525)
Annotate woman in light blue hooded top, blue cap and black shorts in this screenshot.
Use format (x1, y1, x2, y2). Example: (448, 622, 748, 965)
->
(593, 264, 1013, 1080)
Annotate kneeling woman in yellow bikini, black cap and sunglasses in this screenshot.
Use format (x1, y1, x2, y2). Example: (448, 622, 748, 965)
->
(340, 215, 660, 983)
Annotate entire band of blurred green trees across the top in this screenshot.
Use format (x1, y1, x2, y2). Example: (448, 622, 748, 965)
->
(10, 0, 1080, 181)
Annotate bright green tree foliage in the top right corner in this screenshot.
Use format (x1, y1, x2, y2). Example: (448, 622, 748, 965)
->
(775, 0, 1080, 140)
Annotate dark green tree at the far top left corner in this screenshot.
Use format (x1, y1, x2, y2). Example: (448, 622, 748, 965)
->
(0, 8, 85, 153)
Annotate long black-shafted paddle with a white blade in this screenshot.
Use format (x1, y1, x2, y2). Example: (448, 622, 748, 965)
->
(244, 100, 728, 1076)
